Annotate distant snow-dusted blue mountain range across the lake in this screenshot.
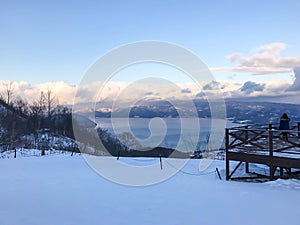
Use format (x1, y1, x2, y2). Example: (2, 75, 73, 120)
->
(95, 100, 300, 123)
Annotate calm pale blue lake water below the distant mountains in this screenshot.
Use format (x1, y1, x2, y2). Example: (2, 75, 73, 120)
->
(96, 118, 235, 149)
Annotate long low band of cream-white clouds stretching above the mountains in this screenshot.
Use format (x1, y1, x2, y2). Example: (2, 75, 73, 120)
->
(0, 78, 299, 105)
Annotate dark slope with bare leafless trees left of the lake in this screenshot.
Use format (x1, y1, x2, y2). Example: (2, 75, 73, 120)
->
(0, 83, 128, 155)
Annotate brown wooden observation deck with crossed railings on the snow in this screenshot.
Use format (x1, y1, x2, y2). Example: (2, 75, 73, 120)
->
(226, 122, 300, 180)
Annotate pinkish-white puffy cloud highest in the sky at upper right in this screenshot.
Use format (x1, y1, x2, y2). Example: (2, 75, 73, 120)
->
(211, 42, 300, 74)
